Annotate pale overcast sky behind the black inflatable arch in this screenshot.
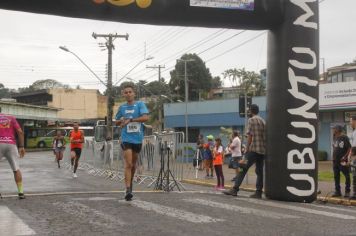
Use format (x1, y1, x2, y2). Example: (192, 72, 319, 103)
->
(0, 0, 356, 91)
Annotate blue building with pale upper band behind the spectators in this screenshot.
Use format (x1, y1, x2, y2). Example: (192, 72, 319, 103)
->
(164, 97, 267, 145)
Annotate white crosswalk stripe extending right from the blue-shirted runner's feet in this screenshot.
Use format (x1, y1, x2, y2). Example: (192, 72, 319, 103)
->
(124, 200, 225, 223)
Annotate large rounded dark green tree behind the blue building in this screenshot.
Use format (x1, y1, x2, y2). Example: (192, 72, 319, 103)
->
(169, 54, 213, 101)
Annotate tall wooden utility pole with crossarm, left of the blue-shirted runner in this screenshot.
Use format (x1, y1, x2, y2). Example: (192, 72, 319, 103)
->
(92, 33, 129, 139)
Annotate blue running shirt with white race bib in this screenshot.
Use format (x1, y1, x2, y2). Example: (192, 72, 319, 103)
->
(115, 101, 148, 144)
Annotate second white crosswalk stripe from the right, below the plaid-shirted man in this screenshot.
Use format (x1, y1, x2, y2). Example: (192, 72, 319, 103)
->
(183, 198, 300, 219)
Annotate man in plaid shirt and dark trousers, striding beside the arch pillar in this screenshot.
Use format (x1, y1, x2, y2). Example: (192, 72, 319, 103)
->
(224, 104, 266, 198)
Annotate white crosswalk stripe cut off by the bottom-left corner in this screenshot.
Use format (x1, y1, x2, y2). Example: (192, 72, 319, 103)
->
(0, 206, 36, 235)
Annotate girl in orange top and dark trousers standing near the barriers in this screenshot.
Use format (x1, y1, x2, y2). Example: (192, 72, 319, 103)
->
(213, 138, 225, 190)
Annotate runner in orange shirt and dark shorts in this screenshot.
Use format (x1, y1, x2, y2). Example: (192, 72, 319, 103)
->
(69, 122, 84, 178)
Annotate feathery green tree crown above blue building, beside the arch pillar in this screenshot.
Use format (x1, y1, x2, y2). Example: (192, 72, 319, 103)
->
(223, 68, 266, 96)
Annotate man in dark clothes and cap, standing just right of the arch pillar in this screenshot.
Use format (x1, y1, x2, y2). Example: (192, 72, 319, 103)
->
(332, 125, 351, 197)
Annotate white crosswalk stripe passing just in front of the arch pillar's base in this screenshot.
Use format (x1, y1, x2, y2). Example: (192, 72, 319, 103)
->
(235, 198, 356, 220)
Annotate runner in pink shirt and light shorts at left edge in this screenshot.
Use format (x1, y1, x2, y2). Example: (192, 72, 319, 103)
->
(0, 113, 25, 199)
